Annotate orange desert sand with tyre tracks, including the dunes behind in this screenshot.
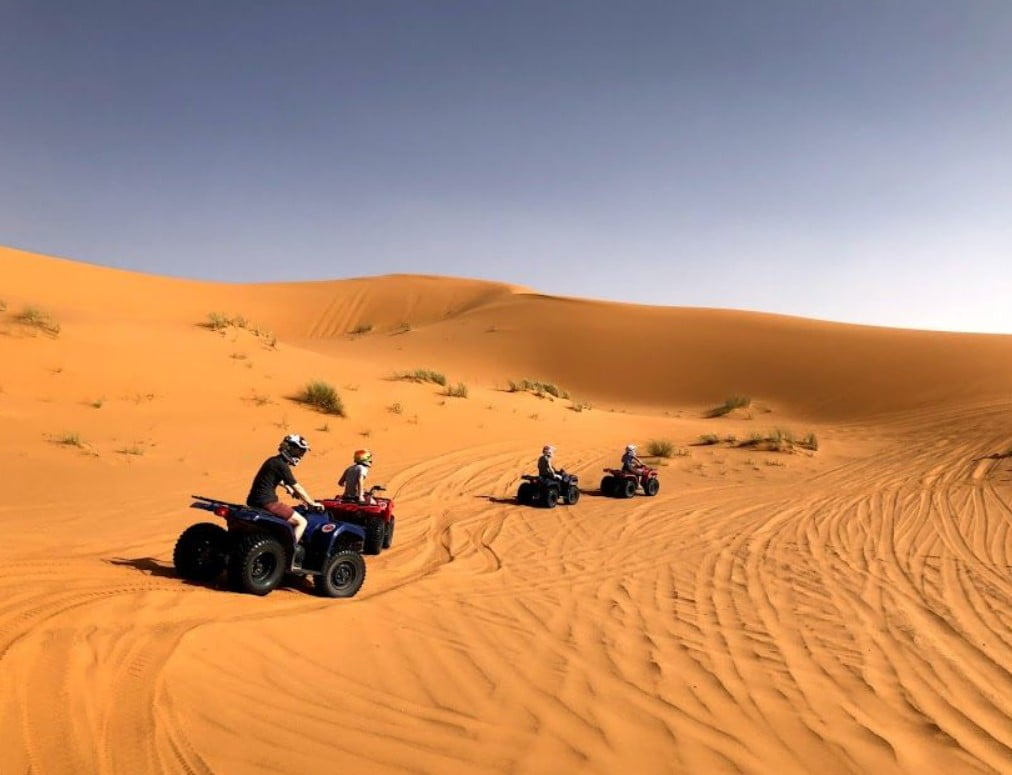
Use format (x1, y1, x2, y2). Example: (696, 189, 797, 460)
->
(0, 244, 1012, 775)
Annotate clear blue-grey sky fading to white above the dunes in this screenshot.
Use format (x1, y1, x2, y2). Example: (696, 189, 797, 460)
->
(0, 0, 1012, 333)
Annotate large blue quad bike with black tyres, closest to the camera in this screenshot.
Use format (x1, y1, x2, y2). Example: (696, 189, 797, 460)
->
(172, 495, 365, 597)
